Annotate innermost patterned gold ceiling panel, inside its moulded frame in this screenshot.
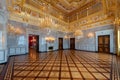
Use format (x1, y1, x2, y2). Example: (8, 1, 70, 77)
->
(35, 0, 92, 13)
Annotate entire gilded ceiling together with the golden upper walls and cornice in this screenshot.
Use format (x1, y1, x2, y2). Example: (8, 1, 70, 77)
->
(7, 0, 115, 31)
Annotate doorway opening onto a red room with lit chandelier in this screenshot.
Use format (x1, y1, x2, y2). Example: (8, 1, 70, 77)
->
(29, 34, 39, 52)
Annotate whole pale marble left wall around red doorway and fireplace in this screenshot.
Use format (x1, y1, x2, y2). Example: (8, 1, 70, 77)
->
(7, 20, 69, 55)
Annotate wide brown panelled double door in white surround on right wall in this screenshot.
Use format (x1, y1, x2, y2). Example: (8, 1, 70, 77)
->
(98, 35, 110, 53)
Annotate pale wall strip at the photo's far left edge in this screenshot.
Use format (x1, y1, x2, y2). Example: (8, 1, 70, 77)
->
(0, 0, 8, 63)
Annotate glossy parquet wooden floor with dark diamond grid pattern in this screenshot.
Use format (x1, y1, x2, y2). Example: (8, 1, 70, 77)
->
(4, 50, 115, 80)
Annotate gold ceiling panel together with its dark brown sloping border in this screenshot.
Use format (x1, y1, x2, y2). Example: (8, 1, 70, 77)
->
(25, 0, 97, 22)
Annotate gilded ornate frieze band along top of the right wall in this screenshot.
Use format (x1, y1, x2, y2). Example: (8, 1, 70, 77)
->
(70, 11, 114, 29)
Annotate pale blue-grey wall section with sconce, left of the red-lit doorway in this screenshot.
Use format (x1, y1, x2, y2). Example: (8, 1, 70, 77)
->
(7, 21, 27, 56)
